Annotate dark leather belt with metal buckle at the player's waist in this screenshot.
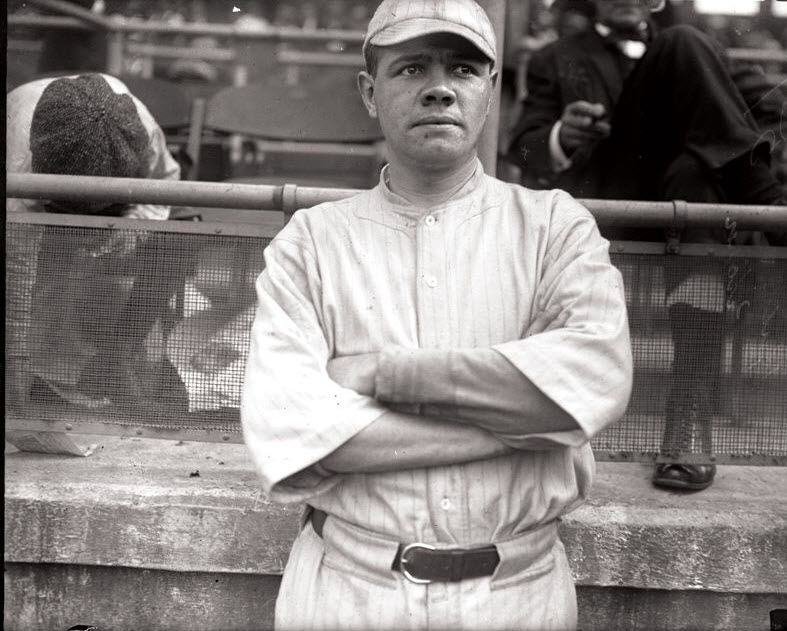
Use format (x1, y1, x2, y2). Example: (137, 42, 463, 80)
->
(311, 508, 500, 583)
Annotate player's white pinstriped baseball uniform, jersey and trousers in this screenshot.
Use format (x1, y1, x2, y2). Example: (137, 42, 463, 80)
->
(242, 163, 631, 629)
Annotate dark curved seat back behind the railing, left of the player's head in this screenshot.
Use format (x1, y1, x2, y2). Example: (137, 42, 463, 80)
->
(189, 68, 383, 188)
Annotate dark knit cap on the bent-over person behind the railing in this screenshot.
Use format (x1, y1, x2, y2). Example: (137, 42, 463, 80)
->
(30, 74, 150, 183)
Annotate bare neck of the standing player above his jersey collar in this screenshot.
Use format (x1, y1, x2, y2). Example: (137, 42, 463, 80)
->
(387, 154, 476, 207)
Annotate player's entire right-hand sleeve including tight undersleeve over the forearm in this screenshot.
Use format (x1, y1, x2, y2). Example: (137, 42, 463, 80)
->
(375, 195, 632, 449)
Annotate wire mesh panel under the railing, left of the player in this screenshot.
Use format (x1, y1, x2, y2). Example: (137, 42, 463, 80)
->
(6, 223, 269, 432)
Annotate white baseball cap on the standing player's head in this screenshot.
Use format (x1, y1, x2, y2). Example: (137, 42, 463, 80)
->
(363, 0, 497, 65)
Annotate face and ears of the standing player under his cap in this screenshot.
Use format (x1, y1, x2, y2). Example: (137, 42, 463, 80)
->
(358, 34, 497, 170)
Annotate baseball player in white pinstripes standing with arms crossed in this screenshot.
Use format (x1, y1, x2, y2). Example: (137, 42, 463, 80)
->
(242, 0, 631, 630)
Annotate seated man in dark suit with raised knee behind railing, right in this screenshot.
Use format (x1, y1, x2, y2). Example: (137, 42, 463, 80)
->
(508, 0, 785, 490)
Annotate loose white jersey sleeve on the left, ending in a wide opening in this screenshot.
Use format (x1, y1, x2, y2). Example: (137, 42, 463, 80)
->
(241, 231, 386, 502)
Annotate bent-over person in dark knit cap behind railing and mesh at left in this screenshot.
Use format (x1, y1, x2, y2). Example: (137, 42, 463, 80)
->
(6, 74, 188, 407)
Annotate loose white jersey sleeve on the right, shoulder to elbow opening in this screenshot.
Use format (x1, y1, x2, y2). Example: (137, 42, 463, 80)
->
(494, 193, 633, 446)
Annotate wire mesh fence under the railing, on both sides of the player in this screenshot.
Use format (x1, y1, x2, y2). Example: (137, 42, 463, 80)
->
(6, 222, 787, 463)
